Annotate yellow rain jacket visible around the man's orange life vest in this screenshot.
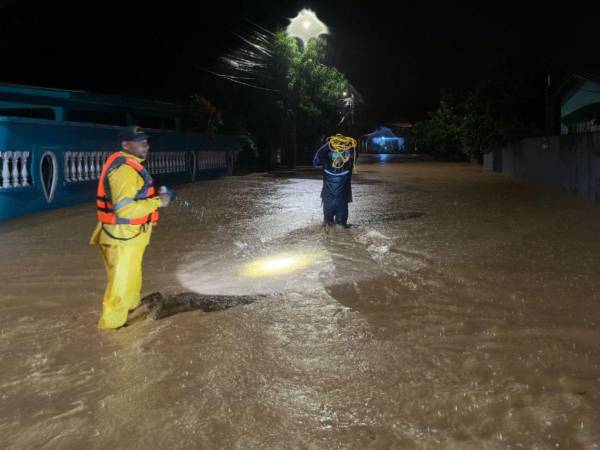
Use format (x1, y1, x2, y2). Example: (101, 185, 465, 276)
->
(90, 153, 162, 246)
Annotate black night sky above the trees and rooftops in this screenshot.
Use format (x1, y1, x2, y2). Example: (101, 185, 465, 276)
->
(0, 0, 600, 125)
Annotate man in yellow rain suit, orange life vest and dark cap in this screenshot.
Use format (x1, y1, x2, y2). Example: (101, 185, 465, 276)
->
(90, 127, 171, 329)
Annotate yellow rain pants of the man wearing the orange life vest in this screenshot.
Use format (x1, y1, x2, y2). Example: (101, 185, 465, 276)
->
(98, 245, 146, 329)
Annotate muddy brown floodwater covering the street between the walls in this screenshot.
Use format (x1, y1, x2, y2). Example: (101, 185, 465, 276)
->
(0, 162, 600, 450)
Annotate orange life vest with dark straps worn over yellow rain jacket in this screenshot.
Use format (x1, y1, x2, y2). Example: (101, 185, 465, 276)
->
(96, 152, 158, 225)
